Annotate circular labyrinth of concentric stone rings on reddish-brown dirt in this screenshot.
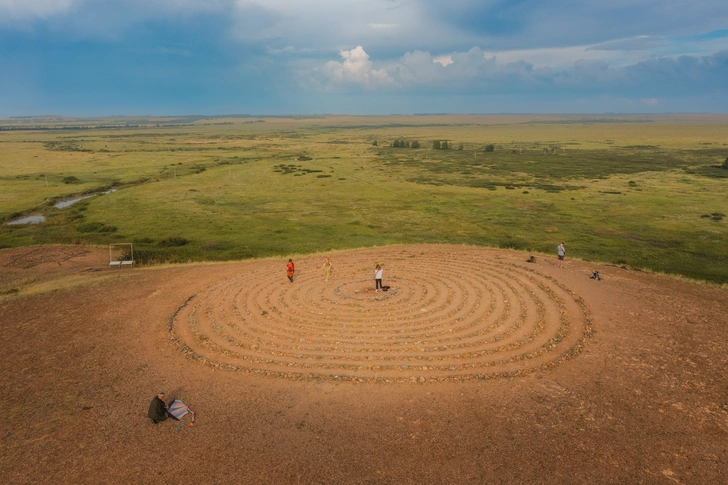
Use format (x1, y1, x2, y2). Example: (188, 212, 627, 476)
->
(169, 246, 592, 383)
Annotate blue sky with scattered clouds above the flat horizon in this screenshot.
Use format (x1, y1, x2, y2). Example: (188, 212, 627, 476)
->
(0, 0, 728, 117)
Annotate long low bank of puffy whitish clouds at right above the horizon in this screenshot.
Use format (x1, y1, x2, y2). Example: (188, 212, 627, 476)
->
(296, 46, 728, 97)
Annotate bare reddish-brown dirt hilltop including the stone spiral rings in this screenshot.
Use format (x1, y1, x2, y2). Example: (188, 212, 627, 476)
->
(0, 245, 728, 484)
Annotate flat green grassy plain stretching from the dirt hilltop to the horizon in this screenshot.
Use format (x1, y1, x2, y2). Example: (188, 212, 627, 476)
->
(0, 115, 728, 283)
